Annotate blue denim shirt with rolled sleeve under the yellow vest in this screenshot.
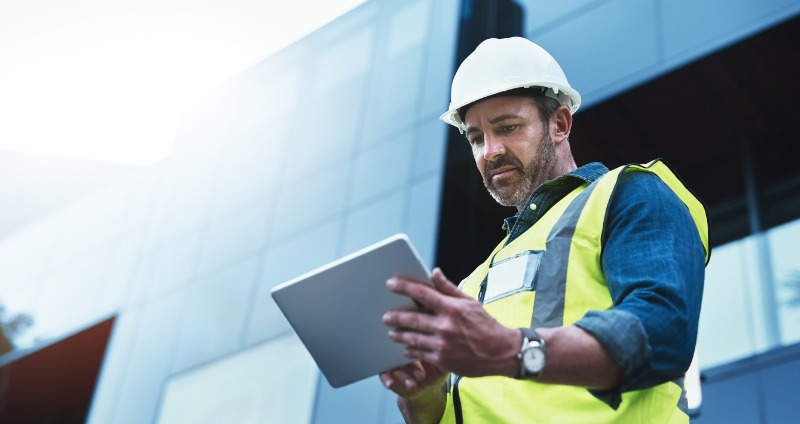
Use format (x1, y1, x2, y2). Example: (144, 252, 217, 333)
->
(503, 163, 705, 408)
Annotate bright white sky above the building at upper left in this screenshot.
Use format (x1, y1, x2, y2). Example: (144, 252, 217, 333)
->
(0, 0, 366, 165)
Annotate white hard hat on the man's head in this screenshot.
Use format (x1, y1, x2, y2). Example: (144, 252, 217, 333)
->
(439, 37, 581, 132)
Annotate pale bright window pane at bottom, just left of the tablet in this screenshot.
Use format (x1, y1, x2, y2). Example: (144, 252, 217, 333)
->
(157, 334, 317, 424)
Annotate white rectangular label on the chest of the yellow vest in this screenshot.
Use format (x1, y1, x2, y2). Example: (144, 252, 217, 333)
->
(484, 250, 544, 303)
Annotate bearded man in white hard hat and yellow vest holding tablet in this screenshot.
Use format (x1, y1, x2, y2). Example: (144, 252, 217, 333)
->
(380, 37, 709, 423)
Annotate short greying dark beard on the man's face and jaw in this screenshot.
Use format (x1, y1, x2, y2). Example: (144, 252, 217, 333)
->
(483, 132, 556, 207)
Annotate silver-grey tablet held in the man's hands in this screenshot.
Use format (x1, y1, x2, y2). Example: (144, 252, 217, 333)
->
(272, 233, 431, 387)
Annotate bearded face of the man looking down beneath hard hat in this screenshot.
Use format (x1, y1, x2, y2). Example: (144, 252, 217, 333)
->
(464, 97, 556, 209)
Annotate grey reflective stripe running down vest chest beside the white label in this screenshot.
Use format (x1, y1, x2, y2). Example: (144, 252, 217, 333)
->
(531, 179, 600, 328)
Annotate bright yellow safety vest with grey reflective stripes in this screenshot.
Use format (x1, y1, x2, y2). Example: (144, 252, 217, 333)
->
(441, 160, 709, 424)
